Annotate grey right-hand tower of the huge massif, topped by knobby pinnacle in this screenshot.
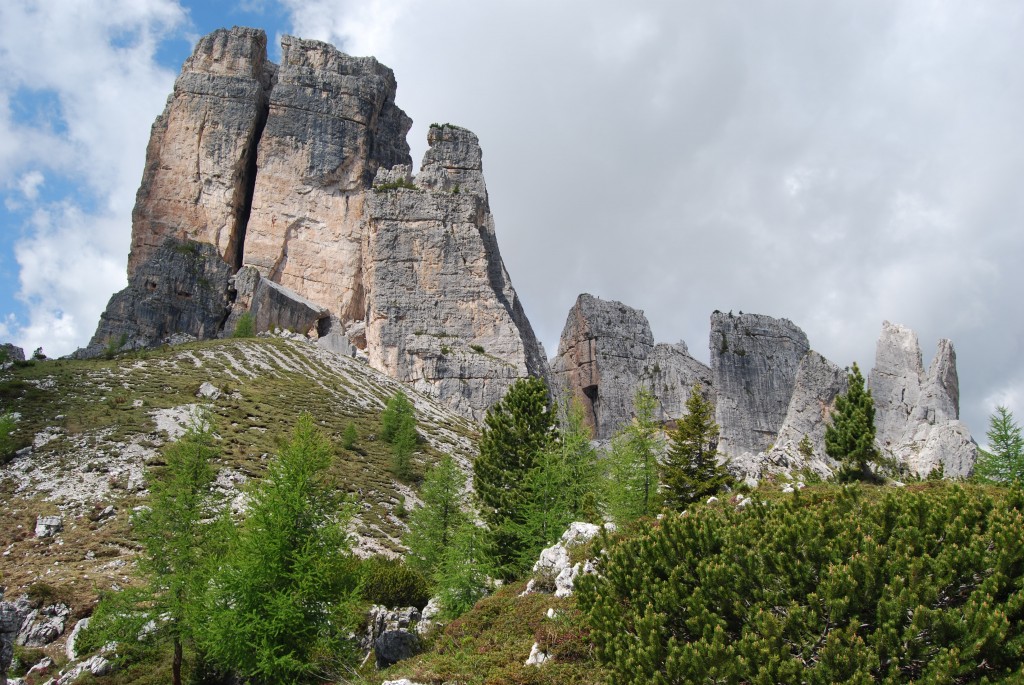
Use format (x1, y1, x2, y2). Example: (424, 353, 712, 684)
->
(364, 125, 547, 419)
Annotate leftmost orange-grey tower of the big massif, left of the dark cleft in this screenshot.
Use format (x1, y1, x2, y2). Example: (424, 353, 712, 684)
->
(128, 27, 275, 272)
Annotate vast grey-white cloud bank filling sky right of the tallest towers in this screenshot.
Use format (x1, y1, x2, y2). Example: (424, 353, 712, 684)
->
(283, 0, 1024, 434)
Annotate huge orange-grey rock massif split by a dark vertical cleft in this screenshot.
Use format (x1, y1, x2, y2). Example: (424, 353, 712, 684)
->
(82, 28, 546, 418)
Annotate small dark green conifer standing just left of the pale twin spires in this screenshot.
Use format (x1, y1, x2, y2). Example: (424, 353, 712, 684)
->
(825, 362, 879, 481)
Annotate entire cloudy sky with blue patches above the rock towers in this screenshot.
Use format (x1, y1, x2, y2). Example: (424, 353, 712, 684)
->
(0, 0, 1024, 443)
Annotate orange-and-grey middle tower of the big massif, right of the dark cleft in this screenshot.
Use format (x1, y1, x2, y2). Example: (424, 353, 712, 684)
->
(244, 36, 412, 320)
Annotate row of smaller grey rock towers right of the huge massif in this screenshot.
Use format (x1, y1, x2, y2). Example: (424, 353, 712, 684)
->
(551, 301, 978, 481)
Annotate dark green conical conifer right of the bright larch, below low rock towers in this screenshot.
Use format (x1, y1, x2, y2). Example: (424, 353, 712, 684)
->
(662, 385, 735, 511)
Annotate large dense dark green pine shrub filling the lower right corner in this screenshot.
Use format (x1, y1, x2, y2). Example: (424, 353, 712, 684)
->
(579, 482, 1024, 684)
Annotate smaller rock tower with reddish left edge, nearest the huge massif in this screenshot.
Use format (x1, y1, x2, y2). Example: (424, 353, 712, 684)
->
(551, 293, 711, 439)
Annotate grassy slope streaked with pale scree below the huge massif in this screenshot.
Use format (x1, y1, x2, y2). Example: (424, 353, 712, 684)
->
(0, 338, 476, 651)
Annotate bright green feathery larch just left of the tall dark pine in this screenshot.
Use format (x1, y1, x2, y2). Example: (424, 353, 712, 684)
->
(402, 455, 468, 579)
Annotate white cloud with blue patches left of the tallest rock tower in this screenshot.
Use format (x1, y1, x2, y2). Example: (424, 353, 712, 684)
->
(0, 0, 186, 355)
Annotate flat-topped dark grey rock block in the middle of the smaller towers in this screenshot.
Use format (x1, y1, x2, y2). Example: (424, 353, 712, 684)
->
(709, 311, 810, 462)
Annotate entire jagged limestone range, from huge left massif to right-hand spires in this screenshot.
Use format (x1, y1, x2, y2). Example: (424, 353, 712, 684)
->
(79, 28, 977, 466)
